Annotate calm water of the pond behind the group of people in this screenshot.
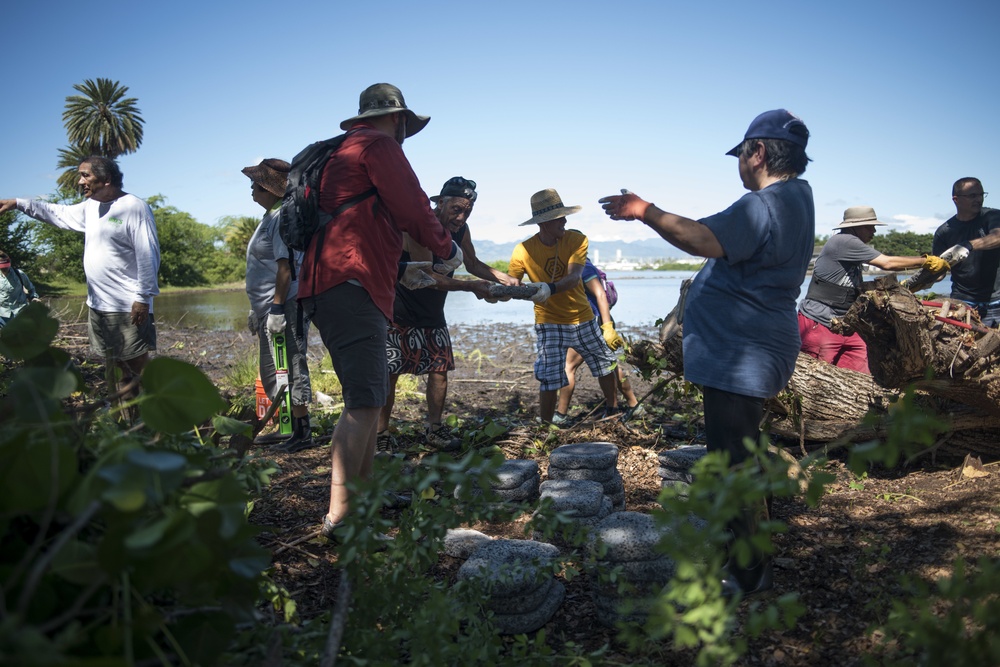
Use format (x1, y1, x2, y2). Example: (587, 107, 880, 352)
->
(51, 271, 951, 331)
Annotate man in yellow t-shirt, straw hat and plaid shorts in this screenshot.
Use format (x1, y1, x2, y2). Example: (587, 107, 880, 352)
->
(507, 189, 622, 422)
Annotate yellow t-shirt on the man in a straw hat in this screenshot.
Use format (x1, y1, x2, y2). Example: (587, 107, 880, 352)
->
(507, 229, 594, 324)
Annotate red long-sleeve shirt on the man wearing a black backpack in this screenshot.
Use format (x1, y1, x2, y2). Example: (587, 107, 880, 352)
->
(299, 122, 451, 320)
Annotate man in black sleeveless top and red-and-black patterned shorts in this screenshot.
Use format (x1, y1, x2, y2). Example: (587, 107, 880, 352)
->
(375, 176, 517, 455)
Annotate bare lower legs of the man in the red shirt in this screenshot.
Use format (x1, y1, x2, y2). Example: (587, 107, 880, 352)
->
(328, 407, 382, 523)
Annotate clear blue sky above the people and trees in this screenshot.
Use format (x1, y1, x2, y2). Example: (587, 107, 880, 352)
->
(0, 0, 1000, 256)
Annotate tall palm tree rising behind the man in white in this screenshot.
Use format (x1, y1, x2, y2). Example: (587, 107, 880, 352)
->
(58, 78, 146, 192)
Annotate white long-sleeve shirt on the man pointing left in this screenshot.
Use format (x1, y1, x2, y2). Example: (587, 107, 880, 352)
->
(17, 194, 160, 313)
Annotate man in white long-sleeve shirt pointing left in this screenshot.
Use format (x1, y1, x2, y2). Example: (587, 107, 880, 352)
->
(0, 155, 160, 394)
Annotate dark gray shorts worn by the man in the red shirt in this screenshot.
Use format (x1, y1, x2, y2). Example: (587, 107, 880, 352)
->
(299, 283, 389, 408)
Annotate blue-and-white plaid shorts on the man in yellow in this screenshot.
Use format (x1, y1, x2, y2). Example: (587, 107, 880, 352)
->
(535, 318, 618, 391)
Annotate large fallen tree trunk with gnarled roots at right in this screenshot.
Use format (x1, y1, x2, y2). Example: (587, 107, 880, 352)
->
(628, 277, 1000, 459)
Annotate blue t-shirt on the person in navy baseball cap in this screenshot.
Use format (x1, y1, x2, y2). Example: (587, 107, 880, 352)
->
(684, 178, 816, 398)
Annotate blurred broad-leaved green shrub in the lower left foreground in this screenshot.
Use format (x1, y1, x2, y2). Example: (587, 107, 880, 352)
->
(0, 304, 269, 665)
